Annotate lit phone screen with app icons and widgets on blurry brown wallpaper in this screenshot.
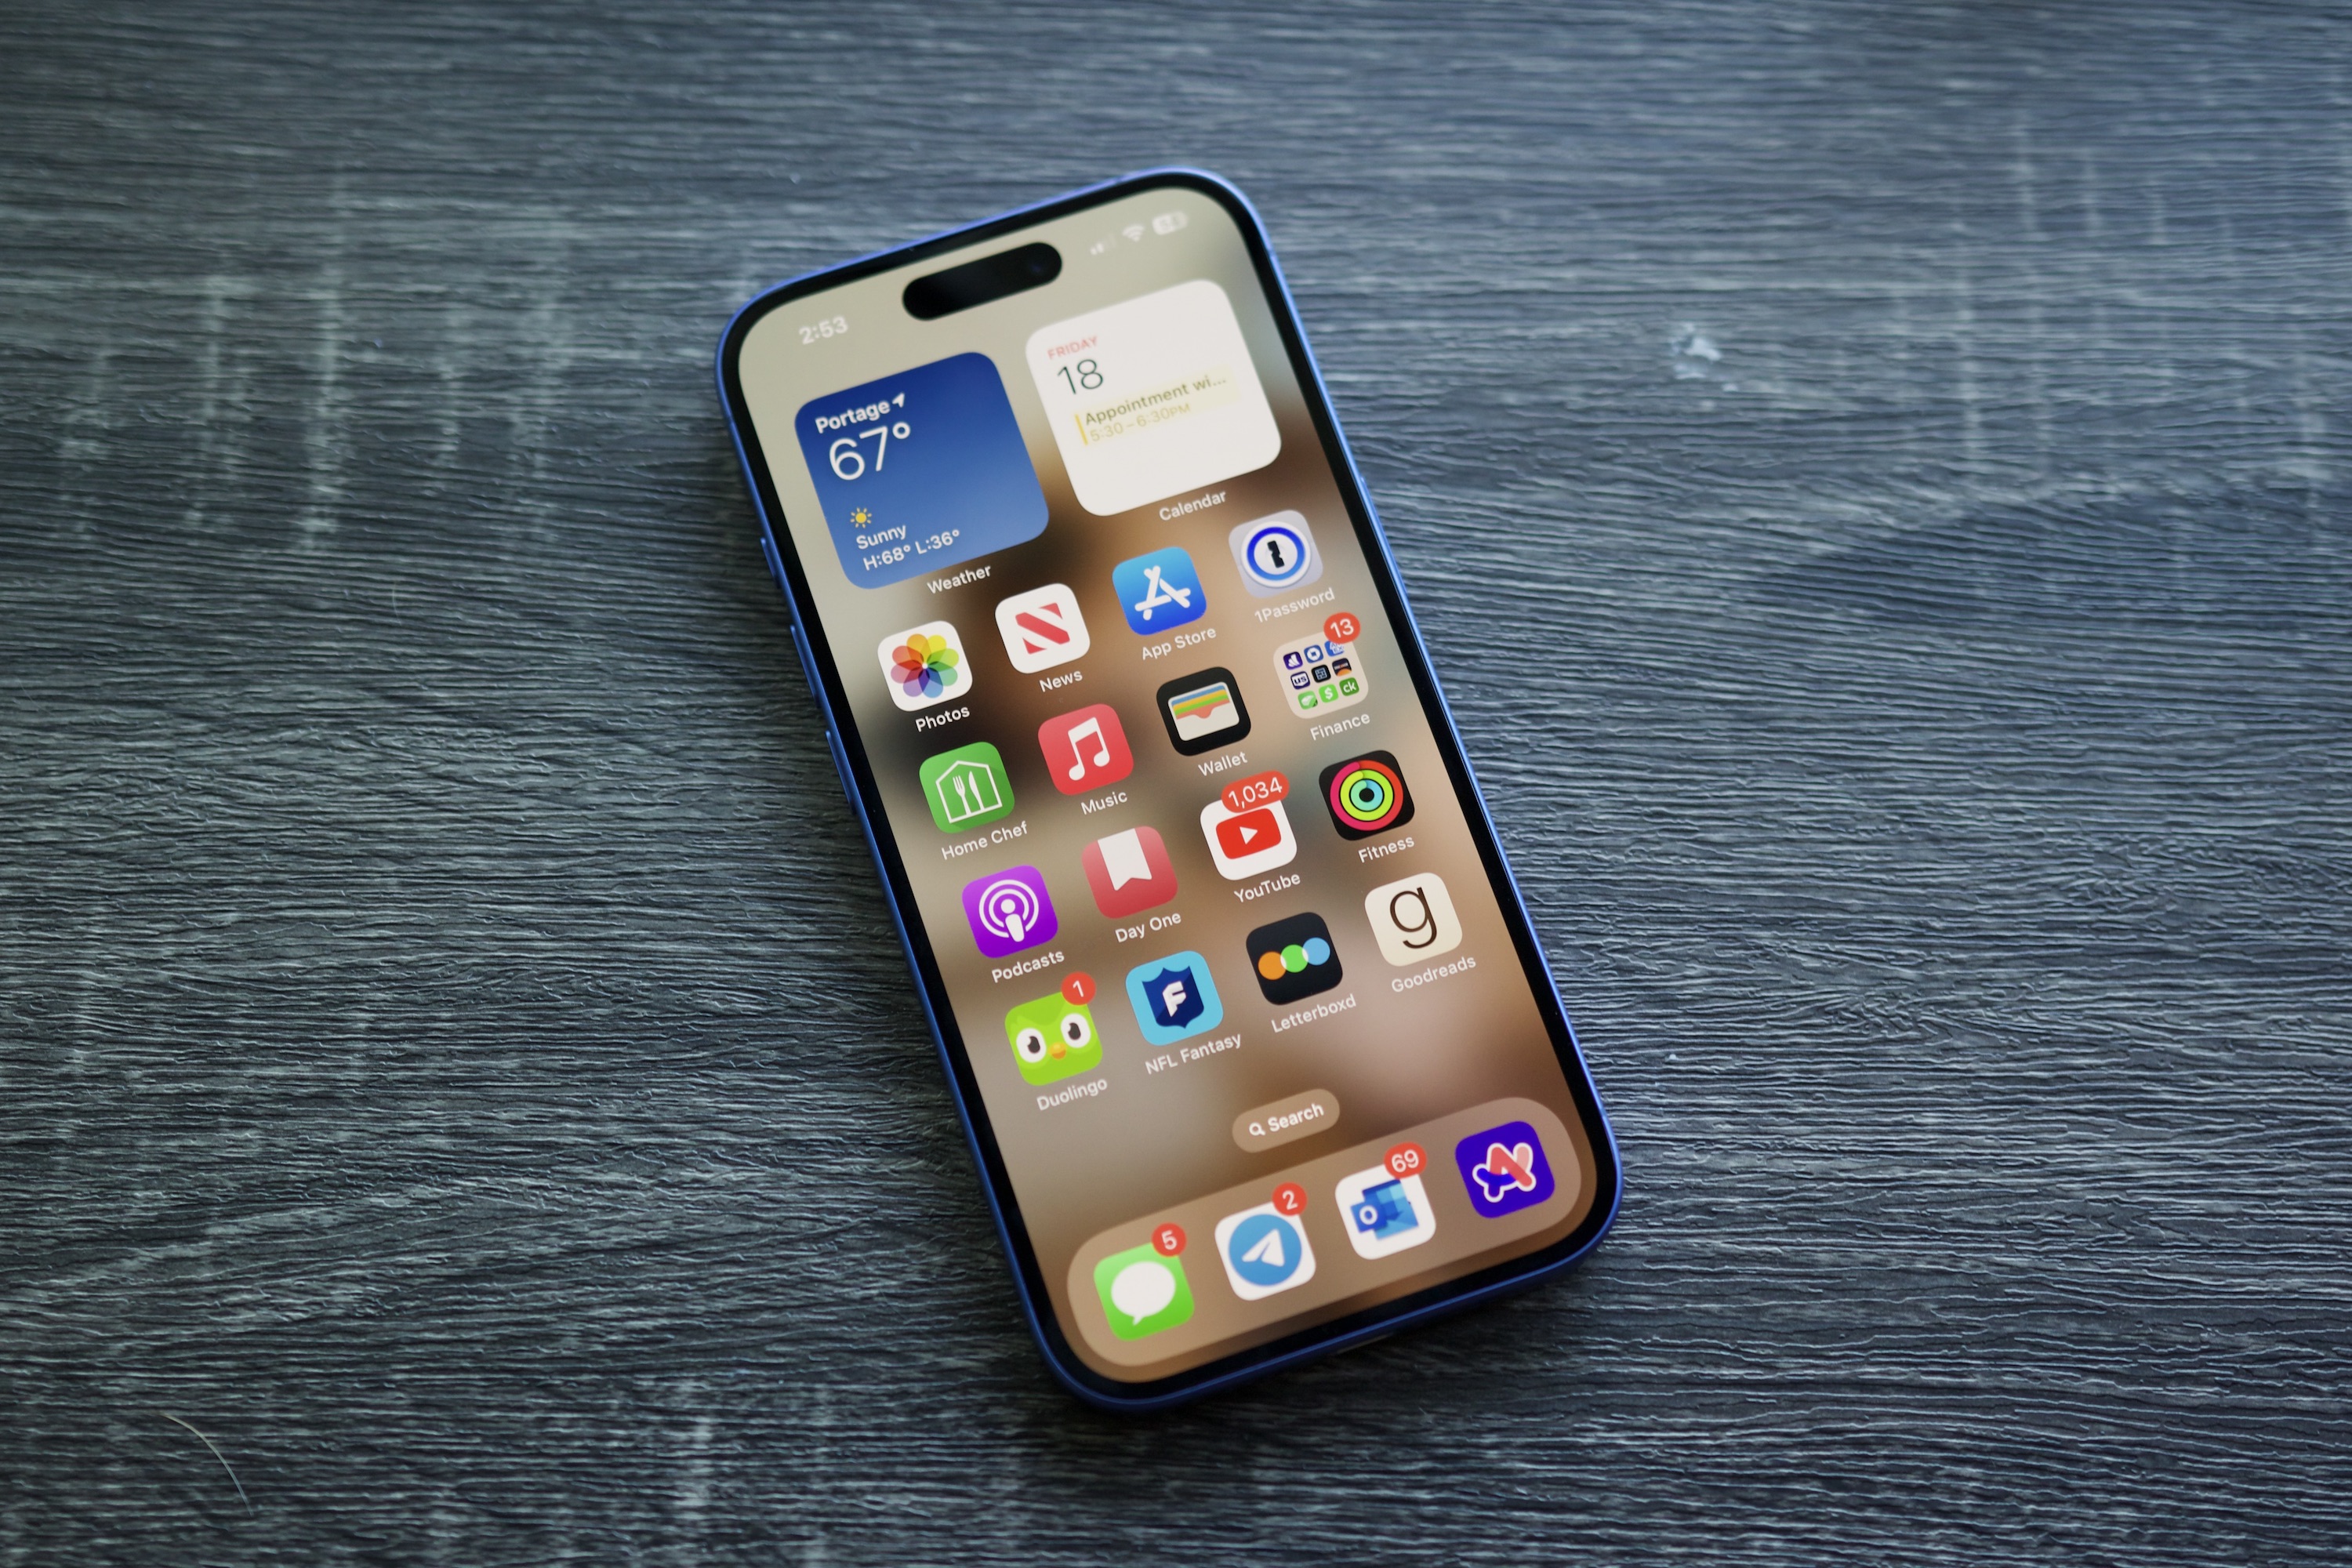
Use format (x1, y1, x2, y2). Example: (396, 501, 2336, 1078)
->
(736, 183, 1599, 1382)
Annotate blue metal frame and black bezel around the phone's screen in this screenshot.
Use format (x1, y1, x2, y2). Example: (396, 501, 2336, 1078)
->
(717, 167, 1625, 1410)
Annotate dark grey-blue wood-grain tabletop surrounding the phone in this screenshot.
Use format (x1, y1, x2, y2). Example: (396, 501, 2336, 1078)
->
(0, 0, 2352, 1568)
